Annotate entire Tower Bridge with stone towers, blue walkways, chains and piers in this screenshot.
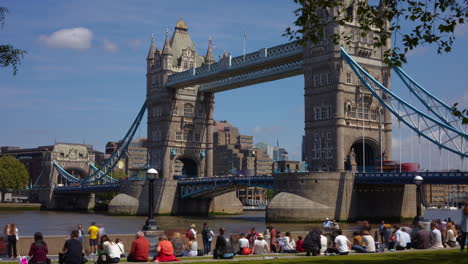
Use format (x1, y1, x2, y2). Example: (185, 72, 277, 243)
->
(35, 14, 468, 221)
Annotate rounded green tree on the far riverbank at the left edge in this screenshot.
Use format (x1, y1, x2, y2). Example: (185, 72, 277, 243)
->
(0, 156, 29, 190)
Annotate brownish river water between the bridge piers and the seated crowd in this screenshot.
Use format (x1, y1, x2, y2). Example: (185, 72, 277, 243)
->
(0, 210, 460, 236)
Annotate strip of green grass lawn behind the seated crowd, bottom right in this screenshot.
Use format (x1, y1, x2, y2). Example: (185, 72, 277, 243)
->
(184, 249, 468, 264)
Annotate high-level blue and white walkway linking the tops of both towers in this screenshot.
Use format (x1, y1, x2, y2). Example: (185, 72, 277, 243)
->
(166, 42, 304, 92)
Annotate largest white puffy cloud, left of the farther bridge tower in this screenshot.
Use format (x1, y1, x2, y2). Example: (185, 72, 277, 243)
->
(39, 27, 93, 49)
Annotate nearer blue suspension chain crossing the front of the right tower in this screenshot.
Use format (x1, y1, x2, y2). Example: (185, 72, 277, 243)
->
(341, 47, 468, 158)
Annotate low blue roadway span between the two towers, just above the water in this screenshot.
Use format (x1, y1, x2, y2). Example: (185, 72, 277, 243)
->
(178, 176, 273, 198)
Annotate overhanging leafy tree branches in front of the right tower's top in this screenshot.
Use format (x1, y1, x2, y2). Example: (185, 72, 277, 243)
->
(284, 0, 468, 124)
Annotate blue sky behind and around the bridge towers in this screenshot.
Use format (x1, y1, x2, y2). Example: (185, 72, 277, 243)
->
(0, 0, 468, 169)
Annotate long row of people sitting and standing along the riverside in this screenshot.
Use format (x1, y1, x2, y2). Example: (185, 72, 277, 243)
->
(4, 202, 468, 264)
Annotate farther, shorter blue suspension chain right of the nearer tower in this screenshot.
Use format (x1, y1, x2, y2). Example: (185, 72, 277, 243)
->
(393, 67, 466, 133)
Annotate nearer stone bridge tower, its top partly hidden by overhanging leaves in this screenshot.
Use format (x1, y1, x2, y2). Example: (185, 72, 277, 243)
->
(304, 1, 392, 171)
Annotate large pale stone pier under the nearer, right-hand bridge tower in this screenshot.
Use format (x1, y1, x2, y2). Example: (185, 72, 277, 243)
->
(266, 172, 416, 222)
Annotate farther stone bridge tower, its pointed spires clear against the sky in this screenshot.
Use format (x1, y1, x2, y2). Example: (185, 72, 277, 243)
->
(146, 19, 214, 179)
